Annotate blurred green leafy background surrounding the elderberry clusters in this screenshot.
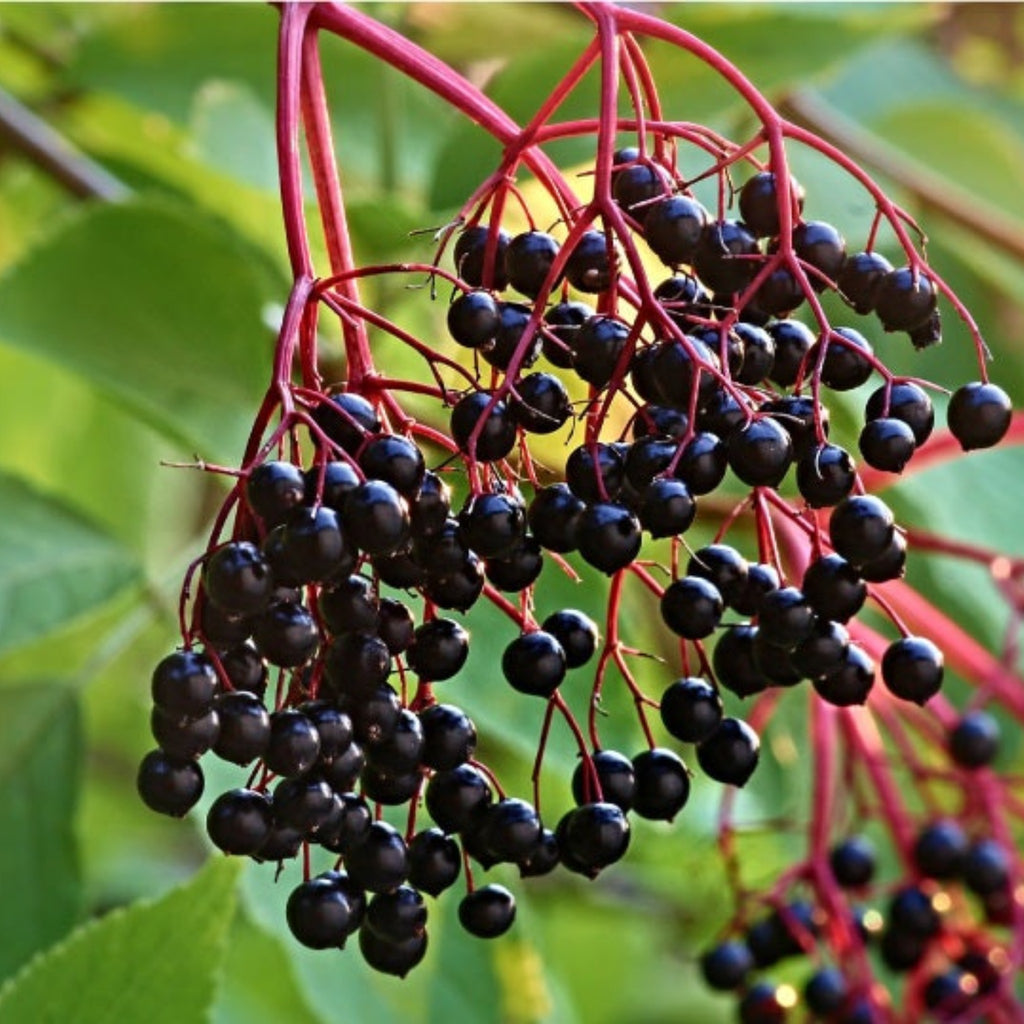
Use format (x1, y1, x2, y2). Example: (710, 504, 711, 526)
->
(0, 3, 1024, 1024)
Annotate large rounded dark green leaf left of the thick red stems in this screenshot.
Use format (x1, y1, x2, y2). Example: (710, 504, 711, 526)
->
(0, 201, 285, 458)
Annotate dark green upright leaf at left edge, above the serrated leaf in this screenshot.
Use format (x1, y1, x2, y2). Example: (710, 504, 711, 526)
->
(0, 681, 82, 977)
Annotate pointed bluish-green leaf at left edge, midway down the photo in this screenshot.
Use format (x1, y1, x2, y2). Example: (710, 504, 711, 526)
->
(0, 473, 138, 651)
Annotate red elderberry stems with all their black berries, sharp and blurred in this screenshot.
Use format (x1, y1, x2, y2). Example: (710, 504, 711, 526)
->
(138, 3, 1024, 1024)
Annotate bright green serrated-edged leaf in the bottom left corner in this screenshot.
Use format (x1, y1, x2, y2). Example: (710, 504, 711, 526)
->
(0, 858, 238, 1024)
